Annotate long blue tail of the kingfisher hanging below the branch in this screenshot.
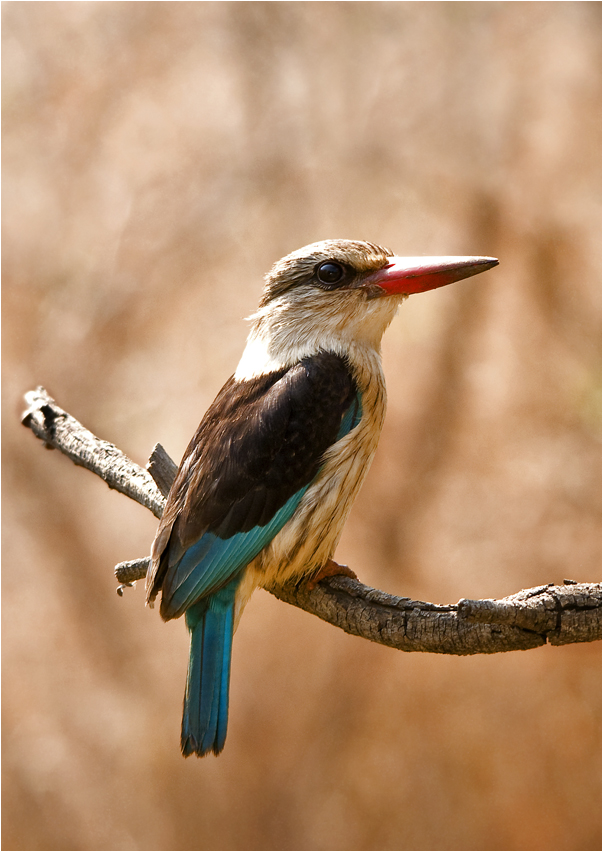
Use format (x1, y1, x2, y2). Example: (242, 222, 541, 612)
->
(180, 576, 241, 757)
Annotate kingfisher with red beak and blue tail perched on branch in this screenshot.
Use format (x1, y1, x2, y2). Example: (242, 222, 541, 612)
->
(146, 240, 498, 757)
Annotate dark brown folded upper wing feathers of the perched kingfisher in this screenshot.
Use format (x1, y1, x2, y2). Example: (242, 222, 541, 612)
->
(148, 352, 356, 600)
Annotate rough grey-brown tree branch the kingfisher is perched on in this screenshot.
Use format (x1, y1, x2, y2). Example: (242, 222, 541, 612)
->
(22, 388, 601, 655)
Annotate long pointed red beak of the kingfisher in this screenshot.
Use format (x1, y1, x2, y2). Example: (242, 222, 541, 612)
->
(362, 257, 498, 296)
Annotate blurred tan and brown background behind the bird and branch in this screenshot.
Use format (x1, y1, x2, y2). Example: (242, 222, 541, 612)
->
(2, 2, 601, 850)
